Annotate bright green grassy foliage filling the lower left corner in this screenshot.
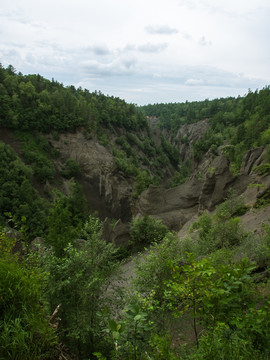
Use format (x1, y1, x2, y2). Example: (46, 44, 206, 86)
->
(0, 230, 56, 360)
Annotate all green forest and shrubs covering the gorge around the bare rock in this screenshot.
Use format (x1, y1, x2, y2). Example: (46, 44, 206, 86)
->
(0, 66, 270, 360)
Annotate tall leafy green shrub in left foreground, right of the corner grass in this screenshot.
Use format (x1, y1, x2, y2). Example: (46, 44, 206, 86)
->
(44, 216, 121, 358)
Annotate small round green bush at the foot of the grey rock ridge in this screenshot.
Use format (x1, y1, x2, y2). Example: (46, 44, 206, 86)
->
(130, 215, 168, 245)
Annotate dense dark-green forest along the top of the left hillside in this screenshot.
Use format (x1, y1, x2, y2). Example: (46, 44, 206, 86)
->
(0, 66, 148, 132)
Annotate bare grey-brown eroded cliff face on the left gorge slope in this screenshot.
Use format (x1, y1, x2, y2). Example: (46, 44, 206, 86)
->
(50, 132, 132, 221)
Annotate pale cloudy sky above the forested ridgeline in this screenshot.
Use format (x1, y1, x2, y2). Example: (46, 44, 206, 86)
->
(0, 0, 270, 105)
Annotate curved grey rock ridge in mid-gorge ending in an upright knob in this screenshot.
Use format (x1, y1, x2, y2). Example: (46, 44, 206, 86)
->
(135, 155, 234, 230)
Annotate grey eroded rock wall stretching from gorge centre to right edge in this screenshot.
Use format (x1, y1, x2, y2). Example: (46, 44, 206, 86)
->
(133, 148, 270, 231)
